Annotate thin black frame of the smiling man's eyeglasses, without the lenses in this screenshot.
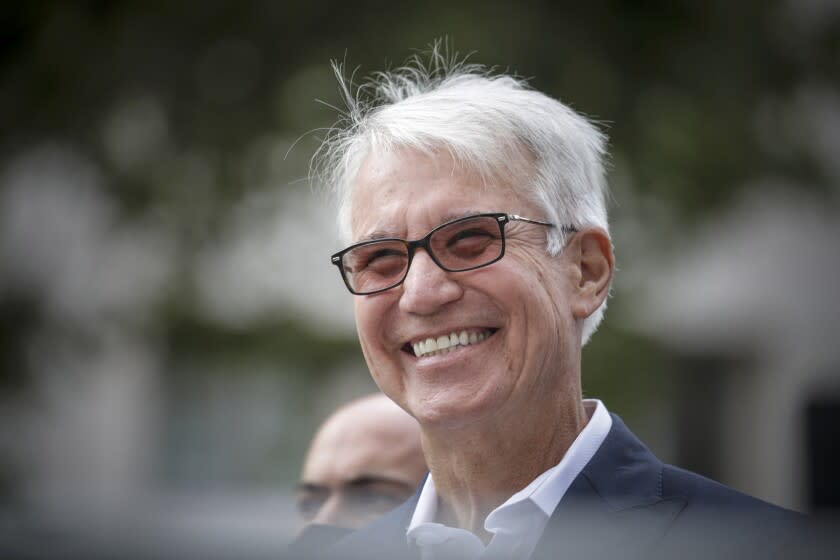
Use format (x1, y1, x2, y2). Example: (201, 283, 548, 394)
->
(330, 212, 577, 296)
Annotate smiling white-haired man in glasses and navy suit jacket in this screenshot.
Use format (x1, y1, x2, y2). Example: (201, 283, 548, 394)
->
(312, 52, 793, 559)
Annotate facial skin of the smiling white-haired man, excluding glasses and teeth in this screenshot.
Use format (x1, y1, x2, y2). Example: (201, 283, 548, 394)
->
(352, 150, 612, 433)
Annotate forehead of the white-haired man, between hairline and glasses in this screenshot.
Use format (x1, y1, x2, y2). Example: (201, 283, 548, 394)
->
(351, 149, 533, 240)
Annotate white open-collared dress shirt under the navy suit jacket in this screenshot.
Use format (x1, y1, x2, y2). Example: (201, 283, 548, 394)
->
(406, 399, 612, 560)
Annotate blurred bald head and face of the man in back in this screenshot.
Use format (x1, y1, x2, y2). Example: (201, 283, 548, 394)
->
(298, 394, 427, 529)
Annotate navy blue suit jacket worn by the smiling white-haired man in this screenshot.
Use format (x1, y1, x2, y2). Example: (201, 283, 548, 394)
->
(300, 414, 801, 560)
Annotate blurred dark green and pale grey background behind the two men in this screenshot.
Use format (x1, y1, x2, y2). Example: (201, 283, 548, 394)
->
(0, 0, 840, 558)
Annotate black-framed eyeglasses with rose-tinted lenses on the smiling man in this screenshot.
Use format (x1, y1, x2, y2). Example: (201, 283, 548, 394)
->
(331, 213, 576, 296)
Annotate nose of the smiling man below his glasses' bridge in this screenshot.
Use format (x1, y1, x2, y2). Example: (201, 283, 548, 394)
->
(400, 250, 463, 315)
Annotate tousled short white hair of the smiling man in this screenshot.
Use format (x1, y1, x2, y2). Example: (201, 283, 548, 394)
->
(313, 48, 609, 344)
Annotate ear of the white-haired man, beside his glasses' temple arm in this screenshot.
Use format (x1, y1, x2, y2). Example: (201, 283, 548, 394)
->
(566, 228, 615, 319)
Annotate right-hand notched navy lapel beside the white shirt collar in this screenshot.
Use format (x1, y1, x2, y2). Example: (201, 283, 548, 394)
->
(532, 415, 685, 560)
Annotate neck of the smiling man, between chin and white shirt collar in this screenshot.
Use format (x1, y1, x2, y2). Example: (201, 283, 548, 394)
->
(423, 392, 588, 542)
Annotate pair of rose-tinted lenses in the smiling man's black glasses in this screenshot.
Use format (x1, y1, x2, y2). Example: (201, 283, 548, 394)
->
(342, 216, 504, 293)
